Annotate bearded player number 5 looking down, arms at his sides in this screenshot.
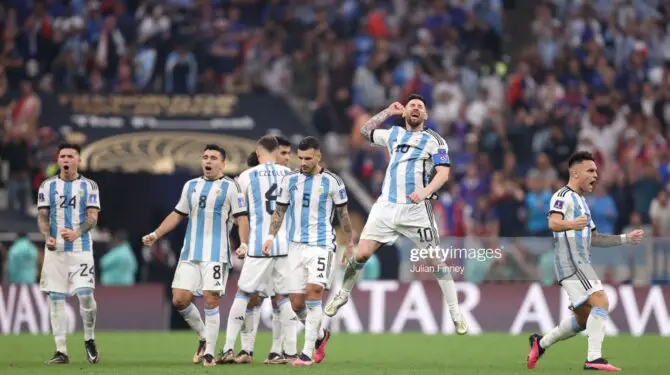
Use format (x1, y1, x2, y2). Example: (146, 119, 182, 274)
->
(263, 137, 353, 366)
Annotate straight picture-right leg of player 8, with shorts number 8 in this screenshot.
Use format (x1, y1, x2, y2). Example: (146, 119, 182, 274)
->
(200, 262, 228, 366)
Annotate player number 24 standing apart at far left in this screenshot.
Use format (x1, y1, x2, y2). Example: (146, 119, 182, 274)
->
(37, 143, 100, 364)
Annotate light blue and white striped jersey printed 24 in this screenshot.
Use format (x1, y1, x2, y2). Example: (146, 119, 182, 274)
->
(37, 175, 100, 252)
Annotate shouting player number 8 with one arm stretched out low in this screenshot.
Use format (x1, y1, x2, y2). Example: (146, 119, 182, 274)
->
(142, 145, 249, 366)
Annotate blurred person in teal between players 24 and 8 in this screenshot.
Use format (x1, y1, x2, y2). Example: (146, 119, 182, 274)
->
(100, 231, 137, 286)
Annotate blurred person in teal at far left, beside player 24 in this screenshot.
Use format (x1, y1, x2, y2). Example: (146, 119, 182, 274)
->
(5, 234, 40, 284)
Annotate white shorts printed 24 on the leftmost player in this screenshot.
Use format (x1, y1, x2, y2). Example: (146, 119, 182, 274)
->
(40, 249, 95, 295)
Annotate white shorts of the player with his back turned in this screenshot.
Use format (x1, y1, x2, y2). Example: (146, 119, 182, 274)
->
(237, 256, 291, 297)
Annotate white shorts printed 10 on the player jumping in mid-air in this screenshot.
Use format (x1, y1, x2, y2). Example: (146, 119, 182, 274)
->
(361, 201, 440, 248)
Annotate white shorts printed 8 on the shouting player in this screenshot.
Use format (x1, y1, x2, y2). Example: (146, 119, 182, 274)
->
(172, 260, 228, 295)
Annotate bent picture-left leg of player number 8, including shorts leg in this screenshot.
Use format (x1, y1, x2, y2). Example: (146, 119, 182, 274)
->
(172, 261, 207, 364)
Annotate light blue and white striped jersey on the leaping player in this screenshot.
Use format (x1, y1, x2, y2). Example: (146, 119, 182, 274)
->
(370, 126, 451, 204)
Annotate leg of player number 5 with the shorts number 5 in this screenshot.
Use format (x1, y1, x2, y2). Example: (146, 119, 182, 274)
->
(293, 247, 334, 366)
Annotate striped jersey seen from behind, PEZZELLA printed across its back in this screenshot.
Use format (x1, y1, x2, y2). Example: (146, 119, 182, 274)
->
(237, 163, 291, 257)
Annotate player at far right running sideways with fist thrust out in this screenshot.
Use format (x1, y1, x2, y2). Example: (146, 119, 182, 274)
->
(528, 151, 644, 371)
